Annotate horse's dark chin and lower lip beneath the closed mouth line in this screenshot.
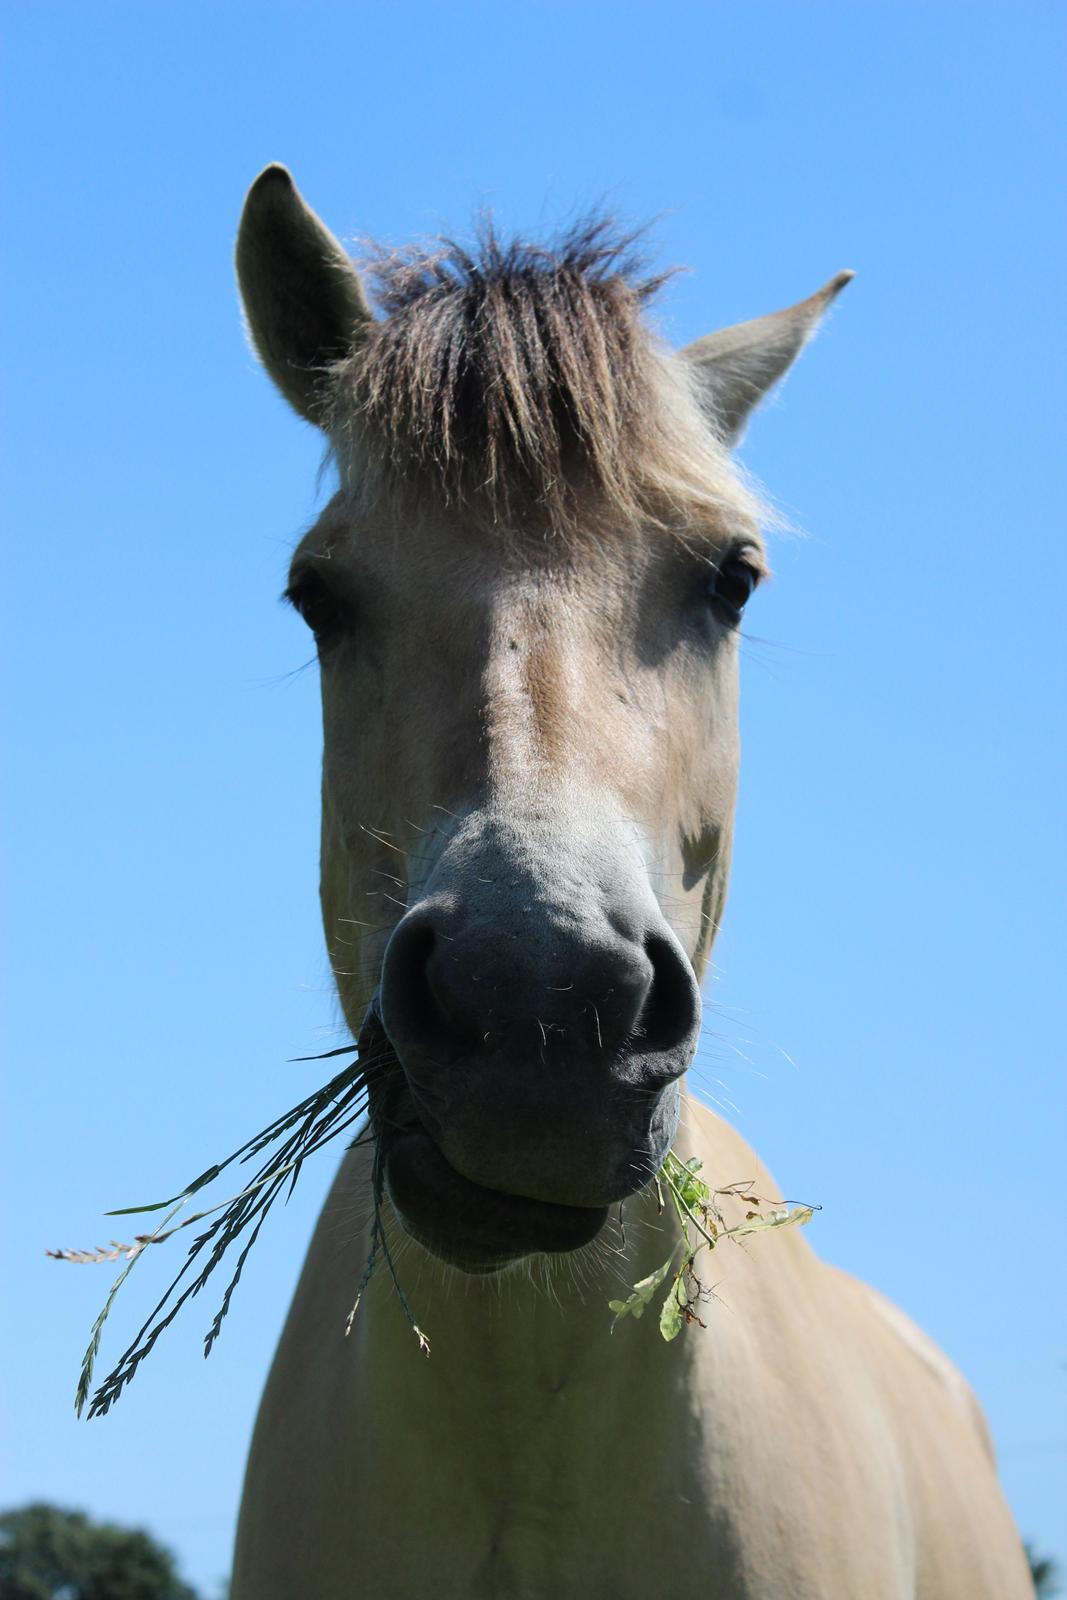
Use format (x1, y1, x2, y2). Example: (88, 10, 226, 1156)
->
(386, 1128, 608, 1274)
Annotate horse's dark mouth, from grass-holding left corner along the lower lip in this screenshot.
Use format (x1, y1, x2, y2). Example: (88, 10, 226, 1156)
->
(360, 1002, 608, 1272)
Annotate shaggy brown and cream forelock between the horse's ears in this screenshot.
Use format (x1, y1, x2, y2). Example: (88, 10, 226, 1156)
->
(330, 218, 752, 530)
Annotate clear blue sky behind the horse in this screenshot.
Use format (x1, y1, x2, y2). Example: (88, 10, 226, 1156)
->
(0, 0, 1067, 1586)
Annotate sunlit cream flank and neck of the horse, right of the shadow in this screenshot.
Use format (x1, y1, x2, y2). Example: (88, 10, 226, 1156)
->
(675, 1107, 1032, 1600)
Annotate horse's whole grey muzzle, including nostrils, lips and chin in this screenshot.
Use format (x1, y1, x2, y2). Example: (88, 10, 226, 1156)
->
(368, 812, 701, 1270)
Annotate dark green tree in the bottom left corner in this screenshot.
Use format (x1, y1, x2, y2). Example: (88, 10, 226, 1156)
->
(0, 1504, 197, 1600)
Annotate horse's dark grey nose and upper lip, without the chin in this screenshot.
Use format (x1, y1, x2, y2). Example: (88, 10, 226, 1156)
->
(381, 814, 701, 1222)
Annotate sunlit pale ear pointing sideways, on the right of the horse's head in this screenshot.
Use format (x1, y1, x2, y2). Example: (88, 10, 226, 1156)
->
(681, 272, 854, 448)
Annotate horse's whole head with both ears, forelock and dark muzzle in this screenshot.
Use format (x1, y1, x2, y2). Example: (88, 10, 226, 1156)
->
(237, 166, 848, 1270)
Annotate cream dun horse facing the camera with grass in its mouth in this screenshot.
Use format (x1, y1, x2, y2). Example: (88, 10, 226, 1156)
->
(232, 165, 1032, 1600)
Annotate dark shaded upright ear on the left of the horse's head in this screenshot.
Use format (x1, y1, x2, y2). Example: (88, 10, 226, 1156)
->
(237, 165, 373, 426)
